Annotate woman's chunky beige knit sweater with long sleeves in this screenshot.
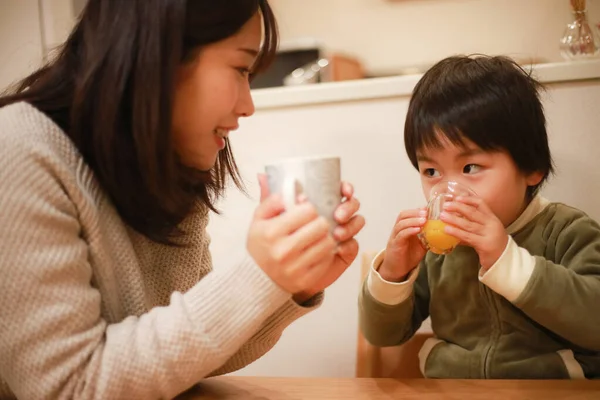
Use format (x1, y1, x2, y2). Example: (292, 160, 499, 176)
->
(0, 103, 321, 399)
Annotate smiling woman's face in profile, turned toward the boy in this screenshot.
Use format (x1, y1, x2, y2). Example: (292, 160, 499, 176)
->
(172, 13, 262, 171)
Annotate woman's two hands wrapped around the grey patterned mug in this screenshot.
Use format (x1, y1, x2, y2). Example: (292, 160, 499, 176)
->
(247, 175, 365, 303)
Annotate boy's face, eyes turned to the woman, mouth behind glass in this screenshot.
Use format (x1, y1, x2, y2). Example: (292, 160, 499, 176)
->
(417, 138, 543, 227)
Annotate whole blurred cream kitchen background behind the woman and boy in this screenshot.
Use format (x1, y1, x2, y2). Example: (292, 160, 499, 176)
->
(0, 0, 600, 377)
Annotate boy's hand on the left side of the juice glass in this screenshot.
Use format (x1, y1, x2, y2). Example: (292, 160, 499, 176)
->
(379, 209, 427, 282)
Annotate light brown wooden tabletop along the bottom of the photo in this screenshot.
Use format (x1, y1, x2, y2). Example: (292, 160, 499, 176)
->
(178, 376, 600, 400)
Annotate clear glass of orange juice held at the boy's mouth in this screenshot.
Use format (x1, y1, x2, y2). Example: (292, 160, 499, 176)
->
(419, 181, 475, 254)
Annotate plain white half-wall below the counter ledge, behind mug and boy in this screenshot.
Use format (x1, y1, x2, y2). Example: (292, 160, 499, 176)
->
(209, 80, 600, 377)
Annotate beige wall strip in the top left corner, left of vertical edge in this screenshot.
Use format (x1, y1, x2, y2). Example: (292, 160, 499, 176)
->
(0, 0, 43, 92)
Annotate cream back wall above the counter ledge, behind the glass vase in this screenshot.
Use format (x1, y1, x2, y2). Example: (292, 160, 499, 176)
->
(271, 0, 600, 73)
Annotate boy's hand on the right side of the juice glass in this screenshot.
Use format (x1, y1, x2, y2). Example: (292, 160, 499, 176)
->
(440, 196, 508, 270)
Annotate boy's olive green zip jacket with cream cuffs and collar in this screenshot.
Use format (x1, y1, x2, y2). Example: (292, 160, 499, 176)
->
(359, 197, 600, 379)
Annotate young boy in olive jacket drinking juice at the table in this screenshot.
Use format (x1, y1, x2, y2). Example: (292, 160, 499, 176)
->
(359, 56, 600, 379)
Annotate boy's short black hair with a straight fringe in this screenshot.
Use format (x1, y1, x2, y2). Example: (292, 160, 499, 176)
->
(404, 55, 554, 195)
